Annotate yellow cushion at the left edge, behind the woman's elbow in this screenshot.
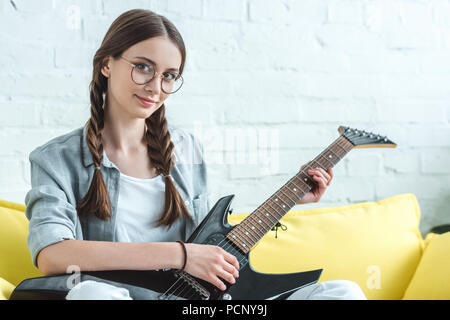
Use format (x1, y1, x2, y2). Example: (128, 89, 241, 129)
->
(0, 200, 42, 286)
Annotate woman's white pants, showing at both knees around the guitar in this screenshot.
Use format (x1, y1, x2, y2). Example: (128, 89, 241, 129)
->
(66, 280, 367, 300)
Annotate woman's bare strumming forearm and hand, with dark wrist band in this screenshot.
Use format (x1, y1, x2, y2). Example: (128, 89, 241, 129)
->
(37, 240, 239, 290)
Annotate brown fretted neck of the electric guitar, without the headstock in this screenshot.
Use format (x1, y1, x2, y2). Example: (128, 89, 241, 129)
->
(226, 136, 354, 253)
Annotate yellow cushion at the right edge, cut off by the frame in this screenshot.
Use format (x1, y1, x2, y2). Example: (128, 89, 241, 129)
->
(403, 232, 450, 300)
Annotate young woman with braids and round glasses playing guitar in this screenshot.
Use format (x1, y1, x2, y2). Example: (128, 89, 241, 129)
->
(25, 9, 364, 299)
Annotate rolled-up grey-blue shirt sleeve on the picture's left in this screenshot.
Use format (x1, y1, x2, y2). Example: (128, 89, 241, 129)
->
(25, 153, 78, 267)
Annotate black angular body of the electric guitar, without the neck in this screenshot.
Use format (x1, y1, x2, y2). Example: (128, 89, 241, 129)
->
(10, 195, 322, 300)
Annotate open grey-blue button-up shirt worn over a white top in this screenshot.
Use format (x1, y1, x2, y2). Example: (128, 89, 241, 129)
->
(25, 126, 210, 266)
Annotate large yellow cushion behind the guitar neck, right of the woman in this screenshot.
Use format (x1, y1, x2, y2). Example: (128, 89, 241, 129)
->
(228, 194, 423, 299)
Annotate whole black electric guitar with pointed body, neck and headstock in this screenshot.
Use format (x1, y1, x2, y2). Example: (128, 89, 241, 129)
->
(10, 126, 396, 300)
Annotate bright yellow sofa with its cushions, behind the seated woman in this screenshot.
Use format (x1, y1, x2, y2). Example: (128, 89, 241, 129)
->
(0, 194, 450, 300)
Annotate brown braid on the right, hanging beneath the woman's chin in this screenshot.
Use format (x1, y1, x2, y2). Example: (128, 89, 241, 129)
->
(145, 104, 192, 227)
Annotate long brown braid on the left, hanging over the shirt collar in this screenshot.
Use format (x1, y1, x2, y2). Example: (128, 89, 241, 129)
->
(77, 73, 112, 220)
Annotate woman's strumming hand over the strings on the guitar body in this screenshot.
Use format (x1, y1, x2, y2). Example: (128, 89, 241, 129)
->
(184, 243, 239, 291)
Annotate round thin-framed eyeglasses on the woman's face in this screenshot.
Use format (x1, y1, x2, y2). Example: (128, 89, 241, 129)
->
(120, 56, 183, 94)
